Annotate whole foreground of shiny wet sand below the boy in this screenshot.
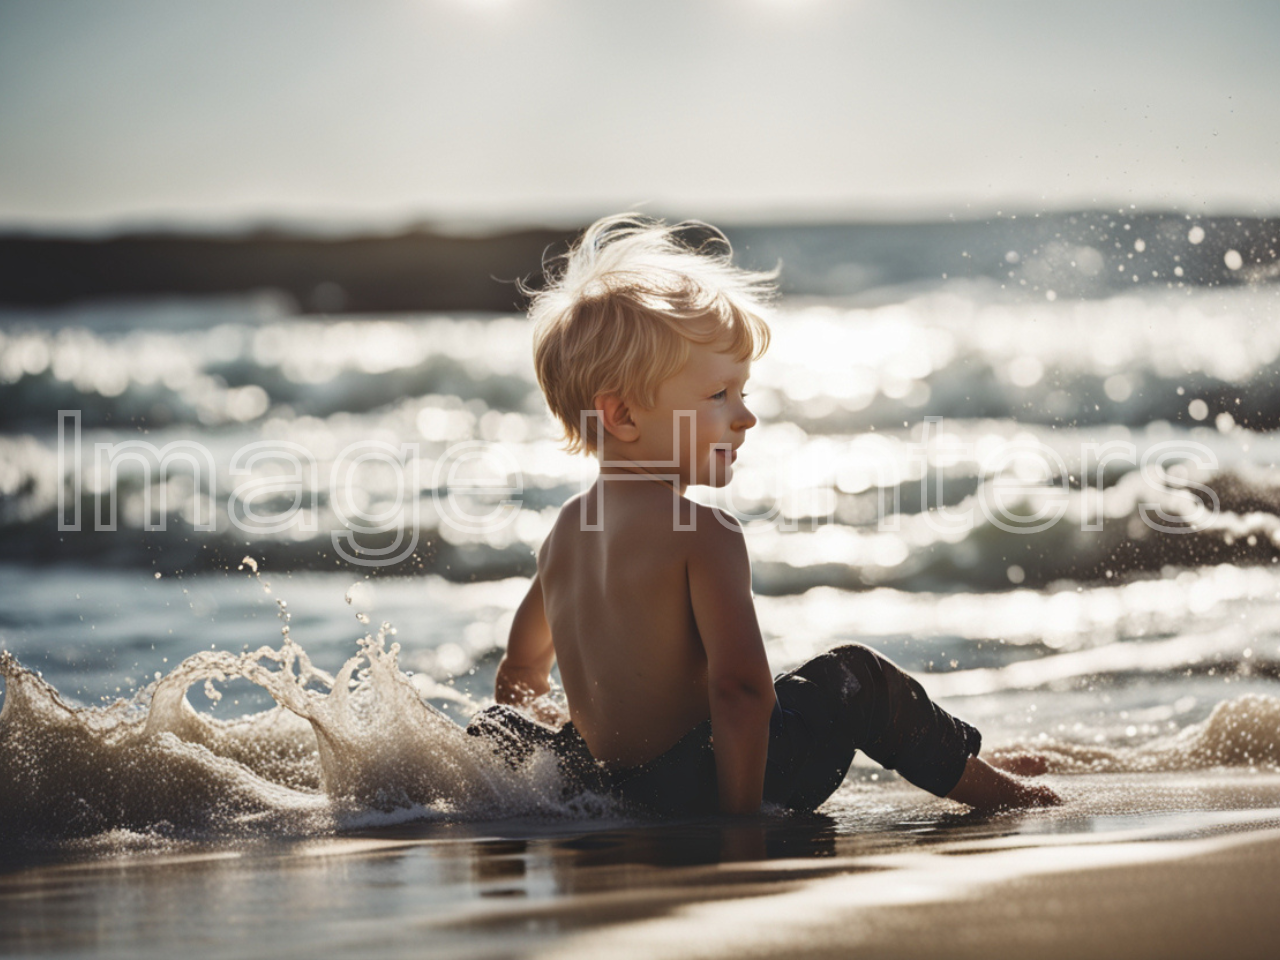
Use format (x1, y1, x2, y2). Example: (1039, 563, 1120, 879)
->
(0, 772, 1280, 959)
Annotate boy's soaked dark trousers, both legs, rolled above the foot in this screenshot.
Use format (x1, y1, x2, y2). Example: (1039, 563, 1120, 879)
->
(467, 644, 982, 817)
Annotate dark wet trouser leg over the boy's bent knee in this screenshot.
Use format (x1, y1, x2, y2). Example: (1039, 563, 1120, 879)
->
(765, 644, 982, 809)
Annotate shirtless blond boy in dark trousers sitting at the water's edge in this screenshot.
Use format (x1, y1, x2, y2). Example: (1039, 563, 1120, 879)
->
(471, 215, 1059, 815)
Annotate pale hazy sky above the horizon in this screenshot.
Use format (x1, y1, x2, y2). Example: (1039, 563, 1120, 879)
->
(0, 0, 1280, 230)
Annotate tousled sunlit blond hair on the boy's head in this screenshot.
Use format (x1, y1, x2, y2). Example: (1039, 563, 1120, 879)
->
(526, 214, 778, 453)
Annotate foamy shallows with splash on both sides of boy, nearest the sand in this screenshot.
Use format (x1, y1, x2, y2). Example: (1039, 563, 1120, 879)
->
(0, 563, 1280, 850)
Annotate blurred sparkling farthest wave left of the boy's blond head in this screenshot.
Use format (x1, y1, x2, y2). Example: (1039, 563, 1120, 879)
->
(0, 317, 538, 430)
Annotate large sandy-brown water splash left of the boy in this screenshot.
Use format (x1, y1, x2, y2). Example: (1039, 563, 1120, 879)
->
(0, 568, 588, 841)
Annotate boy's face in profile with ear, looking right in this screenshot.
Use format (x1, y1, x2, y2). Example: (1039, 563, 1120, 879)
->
(631, 342, 756, 488)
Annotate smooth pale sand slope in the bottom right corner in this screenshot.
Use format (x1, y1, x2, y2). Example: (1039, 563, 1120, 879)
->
(539, 829, 1280, 960)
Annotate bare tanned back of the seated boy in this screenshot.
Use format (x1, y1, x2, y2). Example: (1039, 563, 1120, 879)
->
(538, 477, 710, 767)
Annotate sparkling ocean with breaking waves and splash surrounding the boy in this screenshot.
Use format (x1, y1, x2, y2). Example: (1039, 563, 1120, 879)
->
(0, 218, 1280, 956)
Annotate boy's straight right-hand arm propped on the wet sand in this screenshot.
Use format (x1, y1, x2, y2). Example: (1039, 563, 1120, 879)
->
(689, 513, 776, 814)
